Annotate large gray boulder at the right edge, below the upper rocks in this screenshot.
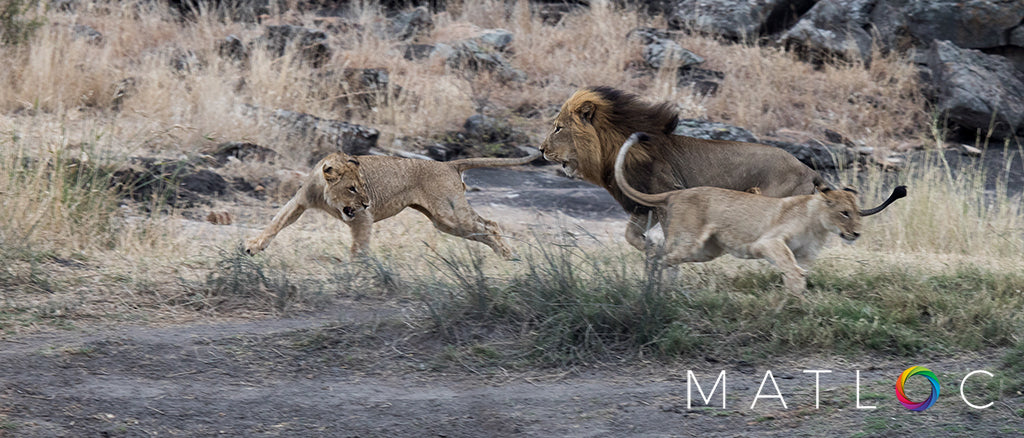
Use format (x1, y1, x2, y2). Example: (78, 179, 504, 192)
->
(926, 41, 1024, 138)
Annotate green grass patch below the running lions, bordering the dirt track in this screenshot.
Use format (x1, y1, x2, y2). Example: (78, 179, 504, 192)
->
(406, 236, 1024, 366)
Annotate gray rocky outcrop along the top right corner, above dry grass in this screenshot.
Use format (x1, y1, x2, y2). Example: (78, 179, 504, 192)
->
(663, 0, 1024, 138)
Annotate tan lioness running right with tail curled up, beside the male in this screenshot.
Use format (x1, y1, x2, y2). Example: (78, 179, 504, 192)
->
(614, 134, 906, 292)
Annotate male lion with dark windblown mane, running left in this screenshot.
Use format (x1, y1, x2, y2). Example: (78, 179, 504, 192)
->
(541, 87, 826, 251)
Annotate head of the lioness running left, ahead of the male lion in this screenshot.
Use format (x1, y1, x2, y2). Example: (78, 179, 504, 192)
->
(321, 154, 370, 222)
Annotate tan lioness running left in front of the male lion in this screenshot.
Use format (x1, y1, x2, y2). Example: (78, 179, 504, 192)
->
(246, 151, 540, 258)
